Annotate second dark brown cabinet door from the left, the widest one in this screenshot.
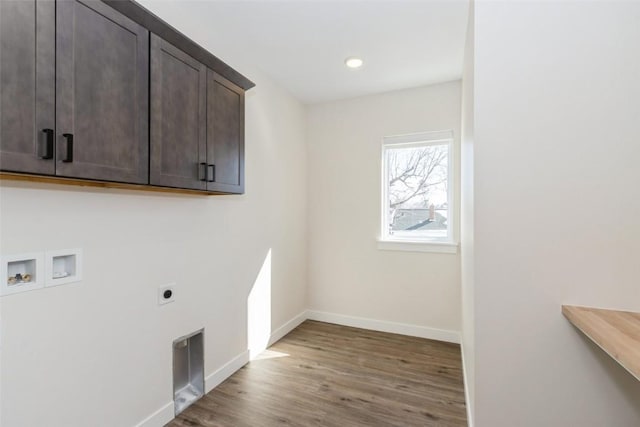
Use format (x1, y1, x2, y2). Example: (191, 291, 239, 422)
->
(56, 0, 149, 184)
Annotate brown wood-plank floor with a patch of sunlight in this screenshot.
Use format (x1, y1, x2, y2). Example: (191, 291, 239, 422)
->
(168, 321, 467, 427)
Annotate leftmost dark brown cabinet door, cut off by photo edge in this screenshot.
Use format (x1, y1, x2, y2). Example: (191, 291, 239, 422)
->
(0, 0, 55, 175)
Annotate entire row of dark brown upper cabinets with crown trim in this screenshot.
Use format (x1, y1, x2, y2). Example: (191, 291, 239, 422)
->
(0, 0, 254, 193)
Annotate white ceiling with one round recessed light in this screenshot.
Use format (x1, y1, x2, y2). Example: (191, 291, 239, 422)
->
(139, 0, 468, 104)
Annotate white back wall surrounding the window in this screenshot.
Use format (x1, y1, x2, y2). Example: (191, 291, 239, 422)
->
(307, 81, 460, 333)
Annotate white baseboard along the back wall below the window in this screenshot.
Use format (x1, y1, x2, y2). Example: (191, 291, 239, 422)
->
(307, 310, 460, 344)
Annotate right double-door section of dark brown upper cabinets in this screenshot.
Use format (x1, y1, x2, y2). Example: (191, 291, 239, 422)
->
(150, 44, 244, 193)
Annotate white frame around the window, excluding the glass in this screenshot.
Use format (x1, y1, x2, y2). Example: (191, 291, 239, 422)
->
(378, 130, 458, 253)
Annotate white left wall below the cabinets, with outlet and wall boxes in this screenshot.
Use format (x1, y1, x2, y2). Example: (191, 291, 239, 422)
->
(0, 70, 307, 427)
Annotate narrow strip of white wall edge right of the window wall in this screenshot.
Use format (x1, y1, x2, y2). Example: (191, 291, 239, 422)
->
(460, 2, 475, 426)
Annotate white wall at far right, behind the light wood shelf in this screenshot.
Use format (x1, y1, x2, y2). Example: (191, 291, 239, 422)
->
(474, 1, 640, 427)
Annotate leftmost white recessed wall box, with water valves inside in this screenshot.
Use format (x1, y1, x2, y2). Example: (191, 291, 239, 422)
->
(0, 252, 45, 295)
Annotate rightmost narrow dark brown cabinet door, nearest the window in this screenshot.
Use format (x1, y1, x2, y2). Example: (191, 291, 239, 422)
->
(207, 70, 244, 193)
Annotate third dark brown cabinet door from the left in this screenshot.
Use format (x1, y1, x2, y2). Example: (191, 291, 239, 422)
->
(150, 34, 207, 190)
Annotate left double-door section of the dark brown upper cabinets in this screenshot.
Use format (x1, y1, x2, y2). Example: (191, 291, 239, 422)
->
(0, 0, 149, 184)
